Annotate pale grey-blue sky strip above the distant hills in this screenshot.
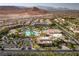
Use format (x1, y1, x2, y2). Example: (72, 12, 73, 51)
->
(0, 3, 79, 10)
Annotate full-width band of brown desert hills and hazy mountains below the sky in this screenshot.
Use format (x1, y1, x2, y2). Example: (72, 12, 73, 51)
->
(0, 6, 79, 17)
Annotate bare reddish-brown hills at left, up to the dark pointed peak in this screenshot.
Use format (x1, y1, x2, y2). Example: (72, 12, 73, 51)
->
(0, 6, 48, 15)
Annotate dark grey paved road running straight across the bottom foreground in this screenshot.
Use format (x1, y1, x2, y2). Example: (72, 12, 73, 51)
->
(0, 50, 79, 56)
